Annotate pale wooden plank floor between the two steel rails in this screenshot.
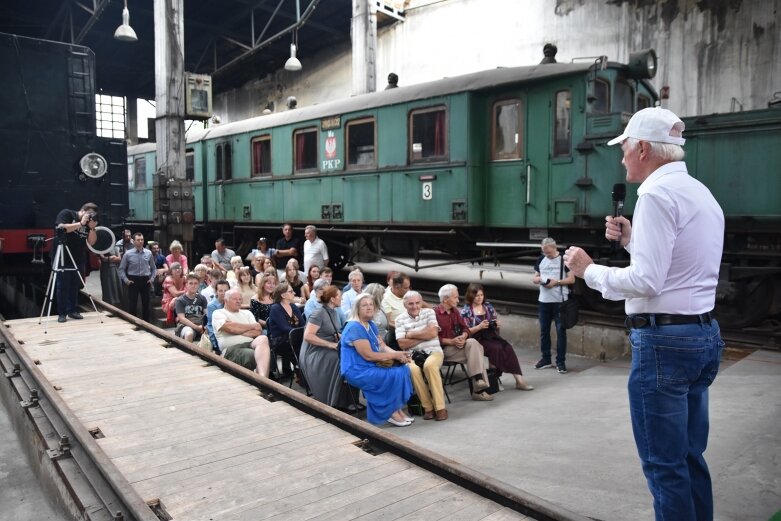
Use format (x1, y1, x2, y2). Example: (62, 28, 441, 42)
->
(6, 312, 529, 521)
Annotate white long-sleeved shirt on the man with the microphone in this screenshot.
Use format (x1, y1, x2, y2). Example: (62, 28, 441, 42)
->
(584, 161, 724, 315)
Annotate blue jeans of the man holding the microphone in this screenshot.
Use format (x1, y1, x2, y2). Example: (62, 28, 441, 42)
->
(628, 320, 724, 521)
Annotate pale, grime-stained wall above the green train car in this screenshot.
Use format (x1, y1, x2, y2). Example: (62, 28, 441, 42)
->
(215, 0, 781, 122)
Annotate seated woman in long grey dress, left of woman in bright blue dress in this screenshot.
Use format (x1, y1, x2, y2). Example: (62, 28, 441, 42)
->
(299, 286, 355, 409)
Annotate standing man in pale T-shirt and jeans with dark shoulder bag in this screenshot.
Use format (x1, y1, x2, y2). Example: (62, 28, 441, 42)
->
(532, 237, 575, 374)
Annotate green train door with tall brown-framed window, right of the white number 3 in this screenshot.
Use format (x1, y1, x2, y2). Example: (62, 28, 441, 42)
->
(485, 96, 527, 228)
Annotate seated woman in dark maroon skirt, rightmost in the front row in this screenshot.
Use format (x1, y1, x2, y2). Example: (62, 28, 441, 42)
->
(461, 284, 534, 391)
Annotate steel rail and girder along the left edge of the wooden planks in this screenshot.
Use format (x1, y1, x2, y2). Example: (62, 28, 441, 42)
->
(0, 318, 160, 521)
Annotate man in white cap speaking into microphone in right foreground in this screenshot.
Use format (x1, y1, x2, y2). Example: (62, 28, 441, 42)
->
(564, 107, 724, 520)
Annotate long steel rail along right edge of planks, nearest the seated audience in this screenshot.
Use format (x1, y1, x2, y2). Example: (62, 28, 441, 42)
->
(84, 297, 593, 521)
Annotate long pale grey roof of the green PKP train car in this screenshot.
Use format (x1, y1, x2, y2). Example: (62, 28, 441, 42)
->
(187, 62, 596, 143)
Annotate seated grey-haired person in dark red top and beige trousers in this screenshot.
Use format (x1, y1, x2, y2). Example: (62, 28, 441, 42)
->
(434, 284, 494, 402)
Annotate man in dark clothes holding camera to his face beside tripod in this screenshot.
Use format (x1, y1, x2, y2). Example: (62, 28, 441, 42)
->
(55, 203, 98, 322)
